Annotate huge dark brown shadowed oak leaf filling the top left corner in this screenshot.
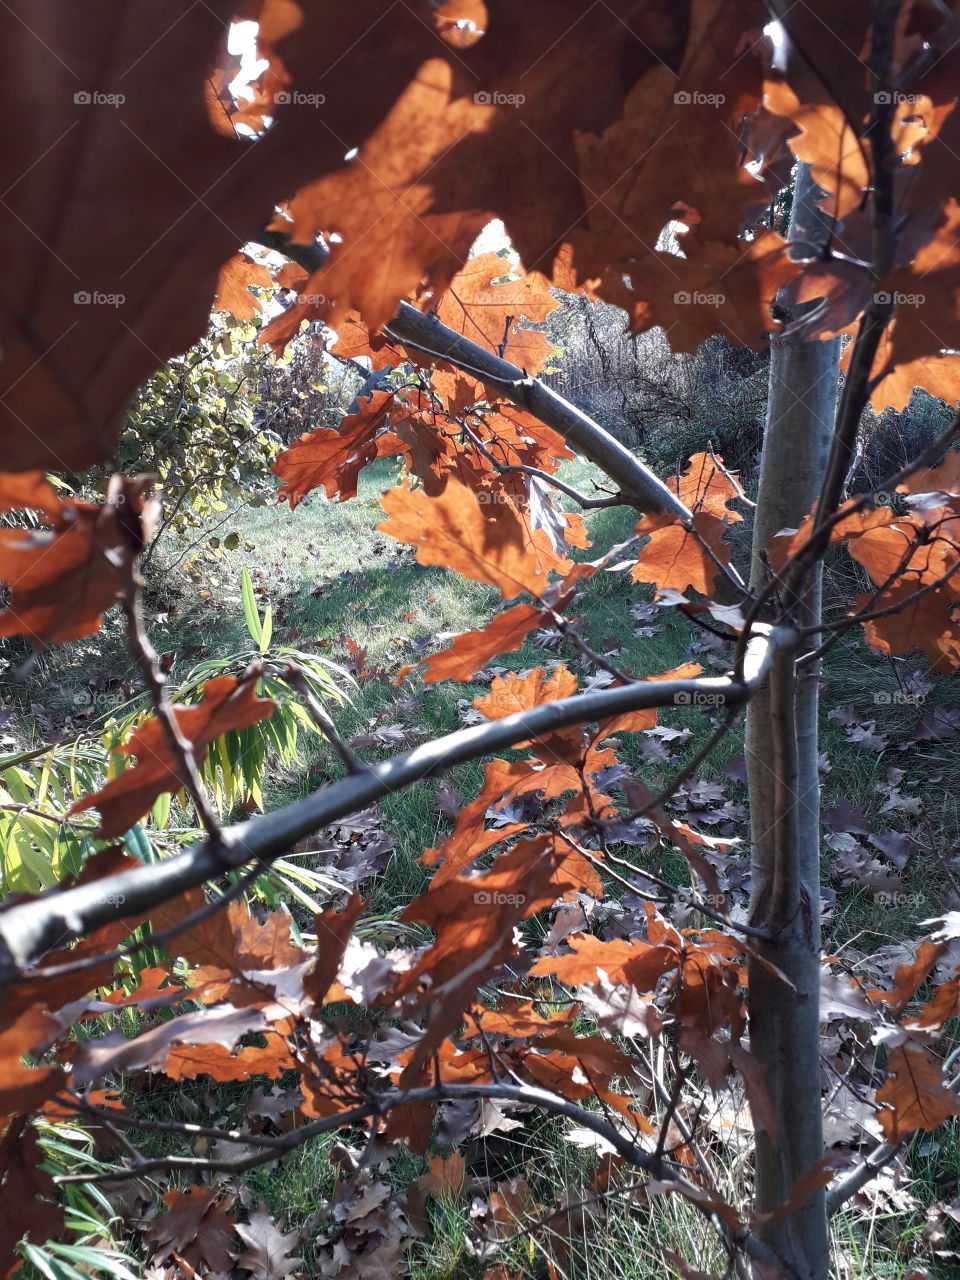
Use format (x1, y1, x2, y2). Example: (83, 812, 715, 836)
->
(0, 0, 442, 471)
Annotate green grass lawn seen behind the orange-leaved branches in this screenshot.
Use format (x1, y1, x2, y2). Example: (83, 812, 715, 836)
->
(4, 462, 960, 1280)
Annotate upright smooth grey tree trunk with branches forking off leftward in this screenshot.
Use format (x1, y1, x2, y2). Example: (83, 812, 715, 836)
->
(746, 165, 840, 1280)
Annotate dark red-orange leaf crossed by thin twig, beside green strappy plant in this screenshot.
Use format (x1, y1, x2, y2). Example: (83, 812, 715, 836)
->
(70, 675, 275, 840)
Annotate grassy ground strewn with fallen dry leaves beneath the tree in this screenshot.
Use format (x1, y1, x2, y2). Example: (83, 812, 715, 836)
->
(3, 462, 960, 1280)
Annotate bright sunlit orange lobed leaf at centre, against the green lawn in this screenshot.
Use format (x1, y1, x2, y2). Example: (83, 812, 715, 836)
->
(376, 477, 572, 599)
